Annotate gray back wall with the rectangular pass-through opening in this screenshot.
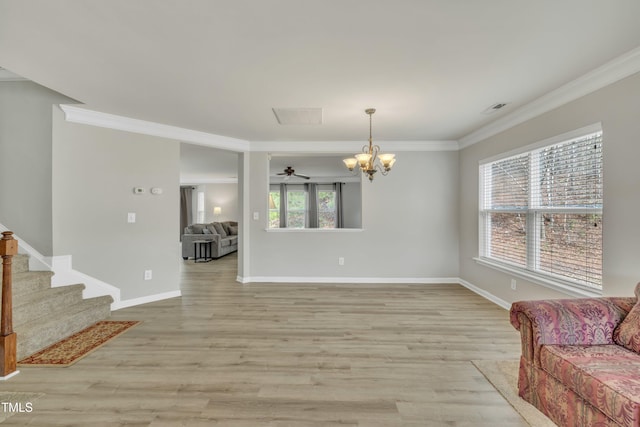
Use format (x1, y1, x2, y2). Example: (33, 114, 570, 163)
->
(245, 152, 458, 278)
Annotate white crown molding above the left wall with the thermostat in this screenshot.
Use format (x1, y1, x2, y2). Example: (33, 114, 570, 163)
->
(60, 104, 249, 152)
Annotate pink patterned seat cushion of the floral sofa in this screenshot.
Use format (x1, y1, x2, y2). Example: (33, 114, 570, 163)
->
(540, 344, 640, 427)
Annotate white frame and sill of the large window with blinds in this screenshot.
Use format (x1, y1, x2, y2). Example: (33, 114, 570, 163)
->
(474, 123, 604, 296)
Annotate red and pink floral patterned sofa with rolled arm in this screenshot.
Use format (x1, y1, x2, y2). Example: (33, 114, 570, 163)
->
(510, 283, 640, 427)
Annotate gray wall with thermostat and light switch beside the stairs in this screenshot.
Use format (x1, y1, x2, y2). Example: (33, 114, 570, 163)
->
(53, 109, 180, 300)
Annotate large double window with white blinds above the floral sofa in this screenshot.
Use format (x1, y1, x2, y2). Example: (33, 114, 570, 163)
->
(480, 129, 603, 289)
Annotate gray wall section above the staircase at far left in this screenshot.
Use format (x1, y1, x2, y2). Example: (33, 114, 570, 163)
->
(0, 81, 75, 256)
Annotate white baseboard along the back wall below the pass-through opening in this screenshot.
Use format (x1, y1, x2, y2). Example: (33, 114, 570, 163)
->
(236, 276, 458, 285)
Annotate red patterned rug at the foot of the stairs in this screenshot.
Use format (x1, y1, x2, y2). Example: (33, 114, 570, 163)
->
(18, 320, 140, 366)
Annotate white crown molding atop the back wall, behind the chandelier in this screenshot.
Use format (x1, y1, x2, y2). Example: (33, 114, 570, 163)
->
(250, 140, 459, 154)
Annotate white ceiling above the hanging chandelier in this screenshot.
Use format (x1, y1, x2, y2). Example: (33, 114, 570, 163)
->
(0, 0, 640, 147)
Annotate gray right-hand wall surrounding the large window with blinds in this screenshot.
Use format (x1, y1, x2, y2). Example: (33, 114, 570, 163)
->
(460, 74, 640, 302)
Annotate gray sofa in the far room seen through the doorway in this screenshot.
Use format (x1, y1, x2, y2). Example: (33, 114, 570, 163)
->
(182, 221, 238, 260)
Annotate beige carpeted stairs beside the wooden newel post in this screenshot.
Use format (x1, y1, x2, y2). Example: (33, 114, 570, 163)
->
(0, 254, 113, 361)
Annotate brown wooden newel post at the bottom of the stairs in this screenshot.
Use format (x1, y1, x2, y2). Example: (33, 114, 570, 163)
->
(0, 231, 18, 378)
